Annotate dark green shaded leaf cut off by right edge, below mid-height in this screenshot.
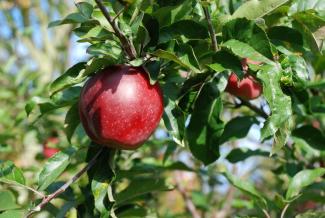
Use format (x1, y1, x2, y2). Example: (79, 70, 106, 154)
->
(292, 126, 325, 151)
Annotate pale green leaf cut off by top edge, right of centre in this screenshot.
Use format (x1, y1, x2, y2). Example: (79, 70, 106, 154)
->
(231, 0, 289, 20)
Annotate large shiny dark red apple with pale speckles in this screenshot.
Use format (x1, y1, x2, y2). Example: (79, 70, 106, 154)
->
(79, 65, 164, 150)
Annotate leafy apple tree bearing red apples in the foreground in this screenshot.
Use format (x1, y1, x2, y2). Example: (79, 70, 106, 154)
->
(0, 0, 325, 218)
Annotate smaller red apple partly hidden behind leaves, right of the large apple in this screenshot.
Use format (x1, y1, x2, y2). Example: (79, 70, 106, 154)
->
(226, 73, 263, 100)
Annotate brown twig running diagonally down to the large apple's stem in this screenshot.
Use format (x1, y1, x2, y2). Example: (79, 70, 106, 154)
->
(95, 0, 137, 60)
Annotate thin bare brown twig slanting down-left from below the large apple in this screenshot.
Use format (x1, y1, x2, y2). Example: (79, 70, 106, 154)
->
(26, 148, 103, 218)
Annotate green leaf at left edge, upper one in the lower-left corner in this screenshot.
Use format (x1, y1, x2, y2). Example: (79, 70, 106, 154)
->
(0, 161, 25, 185)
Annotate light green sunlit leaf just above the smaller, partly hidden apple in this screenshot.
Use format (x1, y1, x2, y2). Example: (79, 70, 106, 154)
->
(221, 39, 274, 65)
